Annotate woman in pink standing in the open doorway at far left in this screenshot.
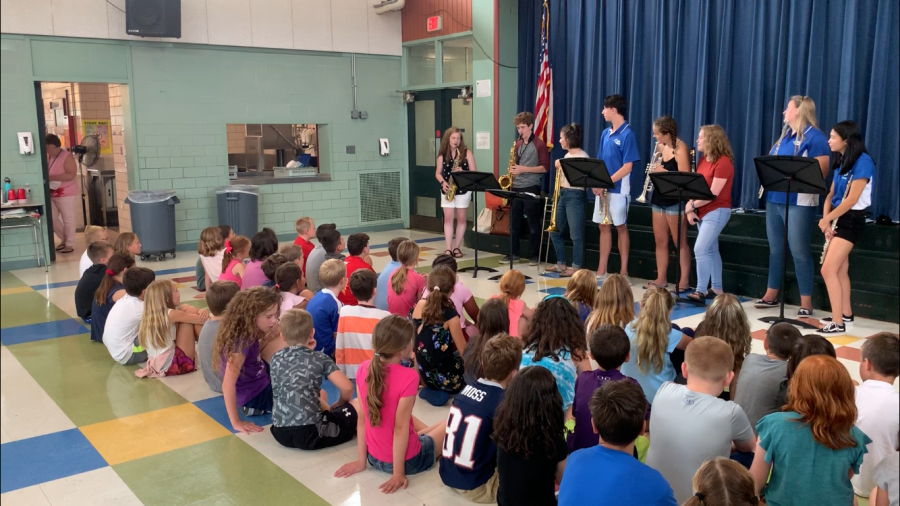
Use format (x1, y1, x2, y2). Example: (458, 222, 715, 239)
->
(44, 134, 78, 253)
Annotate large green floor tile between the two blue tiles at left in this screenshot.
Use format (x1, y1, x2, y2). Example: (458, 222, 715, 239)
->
(8, 334, 188, 427)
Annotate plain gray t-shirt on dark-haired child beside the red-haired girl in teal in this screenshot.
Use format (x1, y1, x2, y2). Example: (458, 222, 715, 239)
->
(734, 354, 787, 433)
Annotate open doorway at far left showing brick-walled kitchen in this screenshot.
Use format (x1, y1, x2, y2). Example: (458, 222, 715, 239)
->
(35, 82, 131, 261)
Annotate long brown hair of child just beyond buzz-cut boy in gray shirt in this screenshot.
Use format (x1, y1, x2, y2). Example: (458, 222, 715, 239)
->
(694, 293, 752, 400)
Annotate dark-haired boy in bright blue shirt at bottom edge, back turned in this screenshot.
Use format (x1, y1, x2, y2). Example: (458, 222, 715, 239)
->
(559, 381, 676, 506)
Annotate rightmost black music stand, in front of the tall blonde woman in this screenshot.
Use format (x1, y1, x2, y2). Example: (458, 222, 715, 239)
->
(753, 155, 828, 330)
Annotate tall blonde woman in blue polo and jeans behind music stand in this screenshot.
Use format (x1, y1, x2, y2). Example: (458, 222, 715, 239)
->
(756, 95, 831, 316)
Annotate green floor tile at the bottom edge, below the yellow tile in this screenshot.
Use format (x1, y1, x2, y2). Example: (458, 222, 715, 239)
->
(113, 436, 328, 506)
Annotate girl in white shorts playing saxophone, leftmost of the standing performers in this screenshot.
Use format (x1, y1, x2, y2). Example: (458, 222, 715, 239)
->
(434, 127, 475, 258)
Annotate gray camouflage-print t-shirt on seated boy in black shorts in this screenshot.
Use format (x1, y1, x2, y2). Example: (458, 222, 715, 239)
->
(271, 346, 338, 427)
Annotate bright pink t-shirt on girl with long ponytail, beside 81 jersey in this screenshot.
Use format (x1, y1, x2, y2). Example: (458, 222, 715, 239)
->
(356, 360, 422, 463)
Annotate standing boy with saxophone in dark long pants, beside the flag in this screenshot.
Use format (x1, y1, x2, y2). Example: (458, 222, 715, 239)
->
(502, 112, 550, 265)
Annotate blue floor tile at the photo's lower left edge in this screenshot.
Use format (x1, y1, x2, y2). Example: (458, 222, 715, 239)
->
(0, 429, 107, 493)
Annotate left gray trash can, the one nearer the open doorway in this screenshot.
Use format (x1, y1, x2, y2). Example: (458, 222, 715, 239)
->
(125, 190, 180, 260)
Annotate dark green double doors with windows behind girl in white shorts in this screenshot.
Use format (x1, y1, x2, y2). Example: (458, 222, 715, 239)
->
(406, 89, 475, 233)
